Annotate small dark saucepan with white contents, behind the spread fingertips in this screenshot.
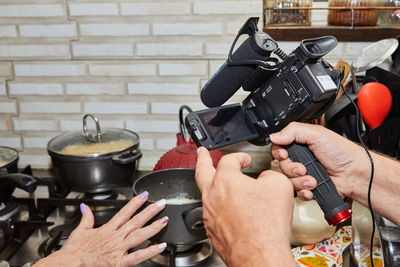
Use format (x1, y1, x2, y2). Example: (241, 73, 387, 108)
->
(133, 168, 207, 252)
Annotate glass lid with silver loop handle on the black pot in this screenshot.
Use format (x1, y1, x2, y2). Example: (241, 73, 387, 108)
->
(47, 114, 139, 157)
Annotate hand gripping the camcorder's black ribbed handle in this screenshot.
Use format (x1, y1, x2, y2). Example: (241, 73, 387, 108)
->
(270, 122, 370, 200)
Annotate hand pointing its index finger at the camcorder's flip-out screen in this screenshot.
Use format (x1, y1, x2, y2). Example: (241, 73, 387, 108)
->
(196, 147, 296, 267)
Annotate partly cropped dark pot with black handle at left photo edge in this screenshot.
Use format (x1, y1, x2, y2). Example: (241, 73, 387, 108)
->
(0, 146, 36, 203)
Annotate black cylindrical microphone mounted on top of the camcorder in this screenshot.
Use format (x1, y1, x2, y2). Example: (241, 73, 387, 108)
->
(200, 31, 277, 108)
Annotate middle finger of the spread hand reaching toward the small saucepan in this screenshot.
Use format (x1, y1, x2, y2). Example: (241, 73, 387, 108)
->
(120, 199, 167, 235)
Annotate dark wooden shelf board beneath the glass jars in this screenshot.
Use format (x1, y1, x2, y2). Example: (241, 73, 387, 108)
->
(264, 25, 400, 42)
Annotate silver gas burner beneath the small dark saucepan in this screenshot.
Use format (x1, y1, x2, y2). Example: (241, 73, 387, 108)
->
(150, 241, 213, 267)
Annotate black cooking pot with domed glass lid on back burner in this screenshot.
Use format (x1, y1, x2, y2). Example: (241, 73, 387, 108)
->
(47, 114, 142, 193)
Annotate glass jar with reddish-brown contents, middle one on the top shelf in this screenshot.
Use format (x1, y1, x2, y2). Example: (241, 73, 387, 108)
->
(328, 0, 381, 26)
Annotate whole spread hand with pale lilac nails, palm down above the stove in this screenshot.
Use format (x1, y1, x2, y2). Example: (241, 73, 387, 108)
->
(34, 192, 168, 267)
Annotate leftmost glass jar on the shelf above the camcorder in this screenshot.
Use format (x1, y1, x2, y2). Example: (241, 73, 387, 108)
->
(264, 0, 312, 26)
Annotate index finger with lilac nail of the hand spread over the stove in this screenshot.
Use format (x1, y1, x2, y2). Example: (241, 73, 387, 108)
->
(104, 191, 149, 230)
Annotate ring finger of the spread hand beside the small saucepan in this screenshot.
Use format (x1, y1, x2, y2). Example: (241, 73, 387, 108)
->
(123, 216, 168, 250)
